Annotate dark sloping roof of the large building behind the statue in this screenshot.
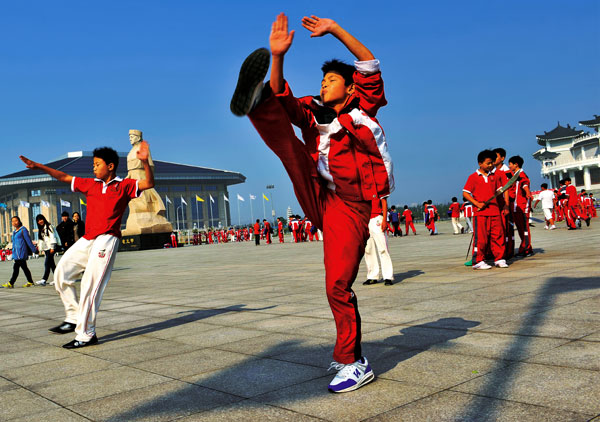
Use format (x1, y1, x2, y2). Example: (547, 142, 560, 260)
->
(0, 151, 246, 186)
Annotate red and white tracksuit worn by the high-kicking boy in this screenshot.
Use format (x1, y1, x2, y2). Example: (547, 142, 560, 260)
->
(248, 60, 394, 364)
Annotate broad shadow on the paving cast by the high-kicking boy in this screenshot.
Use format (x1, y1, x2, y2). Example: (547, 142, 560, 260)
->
(108, 318, 480, 421)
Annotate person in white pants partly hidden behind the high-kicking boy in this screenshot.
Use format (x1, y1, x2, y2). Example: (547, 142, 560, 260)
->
(363, 198, 394, 286)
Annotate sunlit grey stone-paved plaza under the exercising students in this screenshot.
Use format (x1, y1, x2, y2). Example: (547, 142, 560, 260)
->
(0, 220, 600, 422)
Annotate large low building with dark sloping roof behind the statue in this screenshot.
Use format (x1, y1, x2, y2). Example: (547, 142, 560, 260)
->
(0, 151, 246, 243)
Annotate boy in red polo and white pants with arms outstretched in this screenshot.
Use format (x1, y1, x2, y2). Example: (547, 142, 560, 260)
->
(20, 141, 154, 349)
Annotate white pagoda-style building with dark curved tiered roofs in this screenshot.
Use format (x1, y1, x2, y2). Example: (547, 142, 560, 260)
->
(533, 115, 600, 191)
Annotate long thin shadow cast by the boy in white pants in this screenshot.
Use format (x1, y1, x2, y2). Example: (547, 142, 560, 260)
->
(100, 305, 276, 343)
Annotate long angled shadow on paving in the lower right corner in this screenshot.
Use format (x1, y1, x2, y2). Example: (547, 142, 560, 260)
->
(457, 277, 600, 421)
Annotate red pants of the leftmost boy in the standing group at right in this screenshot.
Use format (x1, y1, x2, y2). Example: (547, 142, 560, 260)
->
(472, 215, 504, 265)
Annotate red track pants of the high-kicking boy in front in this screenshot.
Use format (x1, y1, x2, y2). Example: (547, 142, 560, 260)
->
(248, 90, 371, 364)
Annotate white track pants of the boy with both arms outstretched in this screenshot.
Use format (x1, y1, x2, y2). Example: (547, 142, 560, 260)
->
(54, 234, 119, 341)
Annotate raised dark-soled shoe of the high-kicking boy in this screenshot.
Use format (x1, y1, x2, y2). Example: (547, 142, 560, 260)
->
(229, 48, 271, 116)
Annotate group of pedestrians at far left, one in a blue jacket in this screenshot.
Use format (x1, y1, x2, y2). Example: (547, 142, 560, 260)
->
(2, 211, 85, 289)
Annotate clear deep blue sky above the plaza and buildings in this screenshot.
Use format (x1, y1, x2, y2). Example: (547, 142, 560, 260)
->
(0, 0, 600, 221)
